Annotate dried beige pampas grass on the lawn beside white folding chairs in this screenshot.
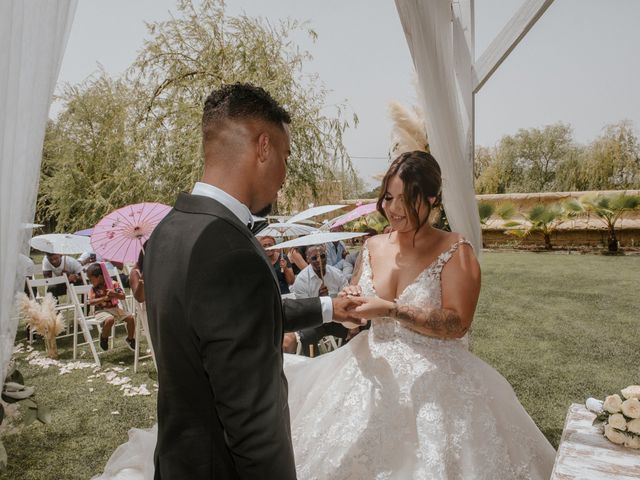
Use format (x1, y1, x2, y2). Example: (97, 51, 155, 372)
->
(16, 292, 64, 358)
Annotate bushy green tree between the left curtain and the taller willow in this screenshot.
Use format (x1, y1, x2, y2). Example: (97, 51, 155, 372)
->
(37, 72, 151, 231)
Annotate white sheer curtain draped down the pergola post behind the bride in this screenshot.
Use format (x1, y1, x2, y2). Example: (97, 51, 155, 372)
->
(396, 0, 482, 254)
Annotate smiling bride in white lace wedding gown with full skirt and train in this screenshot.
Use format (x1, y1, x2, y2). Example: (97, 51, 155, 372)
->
(99, 152, 555, 480)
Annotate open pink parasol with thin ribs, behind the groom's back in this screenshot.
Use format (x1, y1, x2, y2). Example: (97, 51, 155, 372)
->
(91, 203, 171, 263)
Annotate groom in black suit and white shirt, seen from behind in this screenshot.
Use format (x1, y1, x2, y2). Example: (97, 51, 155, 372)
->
(145, 84, 364, 480)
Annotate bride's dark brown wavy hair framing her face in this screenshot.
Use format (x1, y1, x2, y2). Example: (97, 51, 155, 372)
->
(376, 150, 442, 232)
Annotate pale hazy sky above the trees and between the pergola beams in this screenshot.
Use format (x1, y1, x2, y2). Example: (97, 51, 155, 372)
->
(53, 0, 640, 188)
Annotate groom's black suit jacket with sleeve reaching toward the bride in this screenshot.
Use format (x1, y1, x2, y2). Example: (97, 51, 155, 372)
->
(144, 194, 322, 480)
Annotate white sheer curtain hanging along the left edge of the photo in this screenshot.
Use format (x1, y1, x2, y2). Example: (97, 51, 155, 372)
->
(0, 0, 77, 384)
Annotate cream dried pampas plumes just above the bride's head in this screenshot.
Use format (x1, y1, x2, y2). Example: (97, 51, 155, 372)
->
(389, 101, 429, 159)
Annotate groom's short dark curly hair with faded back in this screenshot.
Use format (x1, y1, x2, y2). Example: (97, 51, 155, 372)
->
(202, 83, 291, 142)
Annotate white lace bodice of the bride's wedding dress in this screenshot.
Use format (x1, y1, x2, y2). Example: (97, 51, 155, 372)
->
(358, 239, 471, 346)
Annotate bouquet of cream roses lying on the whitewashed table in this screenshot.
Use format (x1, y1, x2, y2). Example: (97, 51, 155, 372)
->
(586, 385, 640, 449)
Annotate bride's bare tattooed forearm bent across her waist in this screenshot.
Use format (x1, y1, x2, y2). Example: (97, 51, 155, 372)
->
(389, 304, 469, 337)
